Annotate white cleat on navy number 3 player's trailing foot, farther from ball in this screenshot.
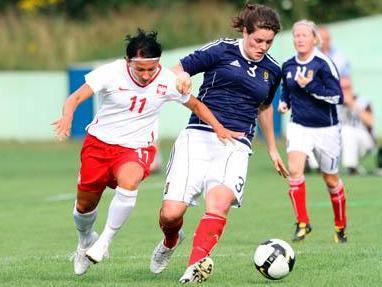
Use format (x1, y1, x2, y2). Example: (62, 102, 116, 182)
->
(150, 229, 185, 274)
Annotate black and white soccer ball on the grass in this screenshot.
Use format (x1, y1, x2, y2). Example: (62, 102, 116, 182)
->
(253, 239, 296, 280)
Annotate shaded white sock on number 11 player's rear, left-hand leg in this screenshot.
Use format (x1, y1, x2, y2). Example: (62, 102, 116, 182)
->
(73, 205, 97, 248)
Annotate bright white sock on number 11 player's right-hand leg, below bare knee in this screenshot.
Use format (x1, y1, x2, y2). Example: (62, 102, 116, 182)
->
(99, 186, 138, 244)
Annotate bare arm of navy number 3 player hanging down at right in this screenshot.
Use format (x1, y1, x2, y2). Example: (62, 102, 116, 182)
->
(258, 104, 289, 177)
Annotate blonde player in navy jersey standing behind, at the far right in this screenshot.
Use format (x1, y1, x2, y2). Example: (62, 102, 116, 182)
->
(279, 20, 347, 243)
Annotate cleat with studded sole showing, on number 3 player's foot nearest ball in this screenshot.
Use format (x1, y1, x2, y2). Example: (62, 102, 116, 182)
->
(179, 257, 214, 284)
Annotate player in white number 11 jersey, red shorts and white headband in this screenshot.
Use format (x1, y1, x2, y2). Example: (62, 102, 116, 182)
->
(54, 29, 240, 275)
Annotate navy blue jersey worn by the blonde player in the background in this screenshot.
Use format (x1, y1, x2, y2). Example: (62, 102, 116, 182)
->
(280, 49, 343, 127)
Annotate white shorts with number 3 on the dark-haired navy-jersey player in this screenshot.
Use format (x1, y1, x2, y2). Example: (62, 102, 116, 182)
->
(163, 129, 251, 207)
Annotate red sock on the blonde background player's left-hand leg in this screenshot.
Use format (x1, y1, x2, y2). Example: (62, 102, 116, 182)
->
(289, 176, 309, 223)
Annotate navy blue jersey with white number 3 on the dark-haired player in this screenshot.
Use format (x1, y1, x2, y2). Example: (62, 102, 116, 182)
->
(180, 39, 281, 145)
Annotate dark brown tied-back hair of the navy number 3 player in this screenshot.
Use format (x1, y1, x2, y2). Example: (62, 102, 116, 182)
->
(232, 3, 281, 34)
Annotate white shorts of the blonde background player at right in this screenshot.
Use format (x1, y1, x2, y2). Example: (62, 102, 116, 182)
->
(286, 122, 341, 174)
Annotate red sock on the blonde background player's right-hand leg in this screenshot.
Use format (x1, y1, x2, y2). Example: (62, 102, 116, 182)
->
(328, 181, 346, 228)
